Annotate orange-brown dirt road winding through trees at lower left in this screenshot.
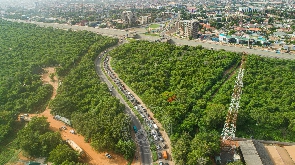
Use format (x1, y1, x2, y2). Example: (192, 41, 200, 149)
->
(31, 68, 127, 165)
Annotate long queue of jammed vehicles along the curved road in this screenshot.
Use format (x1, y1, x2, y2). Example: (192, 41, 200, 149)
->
(103, 52, 168, 164)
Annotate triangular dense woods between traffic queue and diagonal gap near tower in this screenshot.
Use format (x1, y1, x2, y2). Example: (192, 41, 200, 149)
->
(112, 41, 240, 135)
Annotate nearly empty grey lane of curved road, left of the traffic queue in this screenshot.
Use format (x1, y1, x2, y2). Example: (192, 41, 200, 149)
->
(95, 46, 153, 165)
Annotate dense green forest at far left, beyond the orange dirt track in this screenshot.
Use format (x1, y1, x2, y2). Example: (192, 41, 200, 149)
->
(0, 19, 99, 145)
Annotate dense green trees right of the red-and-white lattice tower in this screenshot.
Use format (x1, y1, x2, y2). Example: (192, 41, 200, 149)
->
(238, 56, 295, 141)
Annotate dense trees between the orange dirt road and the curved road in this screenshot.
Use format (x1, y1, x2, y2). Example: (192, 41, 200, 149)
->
(50, 31, 135, 158)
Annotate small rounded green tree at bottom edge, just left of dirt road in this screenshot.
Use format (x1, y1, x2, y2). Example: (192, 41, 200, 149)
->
(48, 144, 78, 165)
